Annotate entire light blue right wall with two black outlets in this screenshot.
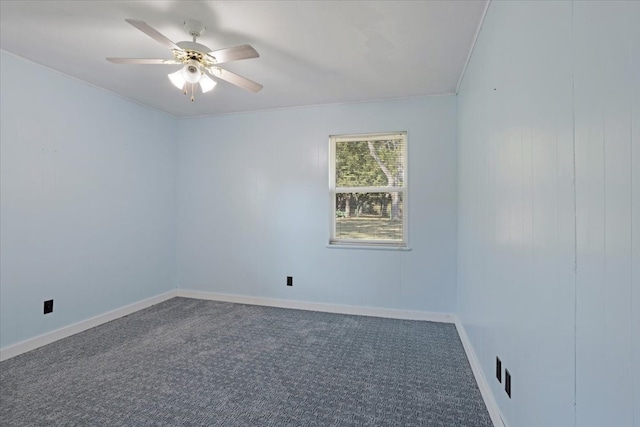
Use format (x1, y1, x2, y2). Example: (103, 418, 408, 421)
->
(458, 1, 640, 427)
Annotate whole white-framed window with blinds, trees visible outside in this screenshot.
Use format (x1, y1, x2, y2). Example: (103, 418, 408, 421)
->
(329, 132, 407, 247)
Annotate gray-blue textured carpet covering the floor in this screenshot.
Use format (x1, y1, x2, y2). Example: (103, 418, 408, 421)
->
(0, 298, 492, 427)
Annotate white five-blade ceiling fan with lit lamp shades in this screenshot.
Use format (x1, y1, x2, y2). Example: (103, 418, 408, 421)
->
(107, 19, 262, 101)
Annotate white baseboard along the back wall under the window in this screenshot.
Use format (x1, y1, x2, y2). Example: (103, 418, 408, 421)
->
(178, 289, 455, 323)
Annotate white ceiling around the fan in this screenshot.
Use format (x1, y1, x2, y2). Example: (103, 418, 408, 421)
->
(0, 0, 487, 117)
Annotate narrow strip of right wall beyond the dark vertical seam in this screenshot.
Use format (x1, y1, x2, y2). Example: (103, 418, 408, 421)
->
(573, 2, 640, 426)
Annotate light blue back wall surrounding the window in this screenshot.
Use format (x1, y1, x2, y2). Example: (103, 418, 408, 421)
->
(177, 96, 457, 313)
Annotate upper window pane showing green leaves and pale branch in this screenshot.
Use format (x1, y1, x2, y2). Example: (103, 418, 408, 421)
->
(336, 138, 405, 187)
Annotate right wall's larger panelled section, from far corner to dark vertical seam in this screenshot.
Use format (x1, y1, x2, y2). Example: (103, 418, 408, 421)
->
(458, 2, 575, 426)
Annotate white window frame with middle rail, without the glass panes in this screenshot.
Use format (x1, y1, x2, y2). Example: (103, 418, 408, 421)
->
(328, 131, 409, 250)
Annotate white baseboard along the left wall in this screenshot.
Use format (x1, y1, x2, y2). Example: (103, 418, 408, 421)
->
(0, 290, 176, 361)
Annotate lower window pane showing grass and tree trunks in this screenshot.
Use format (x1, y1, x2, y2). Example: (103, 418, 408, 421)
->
(335, 193, 403, 242)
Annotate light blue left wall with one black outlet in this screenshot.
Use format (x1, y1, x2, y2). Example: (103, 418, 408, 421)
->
(0, 52, 176, 347)
